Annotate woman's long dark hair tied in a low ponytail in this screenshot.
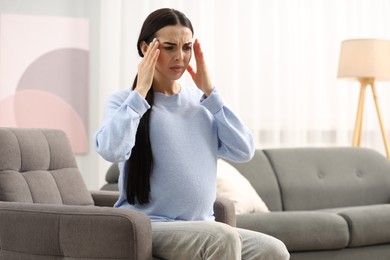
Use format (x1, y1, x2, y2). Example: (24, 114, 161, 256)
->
(126, 8, 194, 205)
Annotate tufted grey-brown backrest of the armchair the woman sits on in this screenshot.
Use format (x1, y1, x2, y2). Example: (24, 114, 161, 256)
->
(0, 128, 94, 205)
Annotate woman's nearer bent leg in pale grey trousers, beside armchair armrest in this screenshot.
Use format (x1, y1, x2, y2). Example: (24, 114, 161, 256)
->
(152, 221, 242, 260)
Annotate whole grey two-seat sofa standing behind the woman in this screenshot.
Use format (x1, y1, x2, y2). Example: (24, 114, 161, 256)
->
(103, 147, 390, 260)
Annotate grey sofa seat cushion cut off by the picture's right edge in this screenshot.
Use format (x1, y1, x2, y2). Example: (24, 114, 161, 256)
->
(324, 204, 390, 247)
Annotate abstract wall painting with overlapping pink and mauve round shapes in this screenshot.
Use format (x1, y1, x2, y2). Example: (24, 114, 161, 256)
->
(0, 14, 89, 154)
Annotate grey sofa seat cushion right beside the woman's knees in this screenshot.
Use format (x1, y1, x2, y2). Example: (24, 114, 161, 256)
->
(237, 211, 349, 252)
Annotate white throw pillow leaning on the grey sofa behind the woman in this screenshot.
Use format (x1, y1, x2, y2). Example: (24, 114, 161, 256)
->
(217, 159, 269, 214)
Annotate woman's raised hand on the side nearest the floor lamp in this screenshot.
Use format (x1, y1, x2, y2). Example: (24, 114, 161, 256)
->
(187, 39, 214, 96)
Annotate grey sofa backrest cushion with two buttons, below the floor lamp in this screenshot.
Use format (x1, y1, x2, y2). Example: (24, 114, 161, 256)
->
(264, 147, 390, 210)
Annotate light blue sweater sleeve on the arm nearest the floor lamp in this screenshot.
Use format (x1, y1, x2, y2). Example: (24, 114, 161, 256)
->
(201, 88, 255, 162)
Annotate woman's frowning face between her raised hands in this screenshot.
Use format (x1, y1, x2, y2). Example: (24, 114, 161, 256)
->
(155, 25, 192, 81)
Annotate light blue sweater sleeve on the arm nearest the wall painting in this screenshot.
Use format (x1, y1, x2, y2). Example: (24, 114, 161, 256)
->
(94, 90, 150, 162)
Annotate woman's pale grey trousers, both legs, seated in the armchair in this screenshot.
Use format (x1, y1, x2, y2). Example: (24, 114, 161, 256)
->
(152, 221, 290, 260)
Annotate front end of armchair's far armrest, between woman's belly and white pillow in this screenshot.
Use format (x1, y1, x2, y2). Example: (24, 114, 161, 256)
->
(214, 197, 236, 227)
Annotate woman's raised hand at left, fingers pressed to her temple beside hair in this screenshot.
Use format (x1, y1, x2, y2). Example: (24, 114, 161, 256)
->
(134, 38, 160, 97)
